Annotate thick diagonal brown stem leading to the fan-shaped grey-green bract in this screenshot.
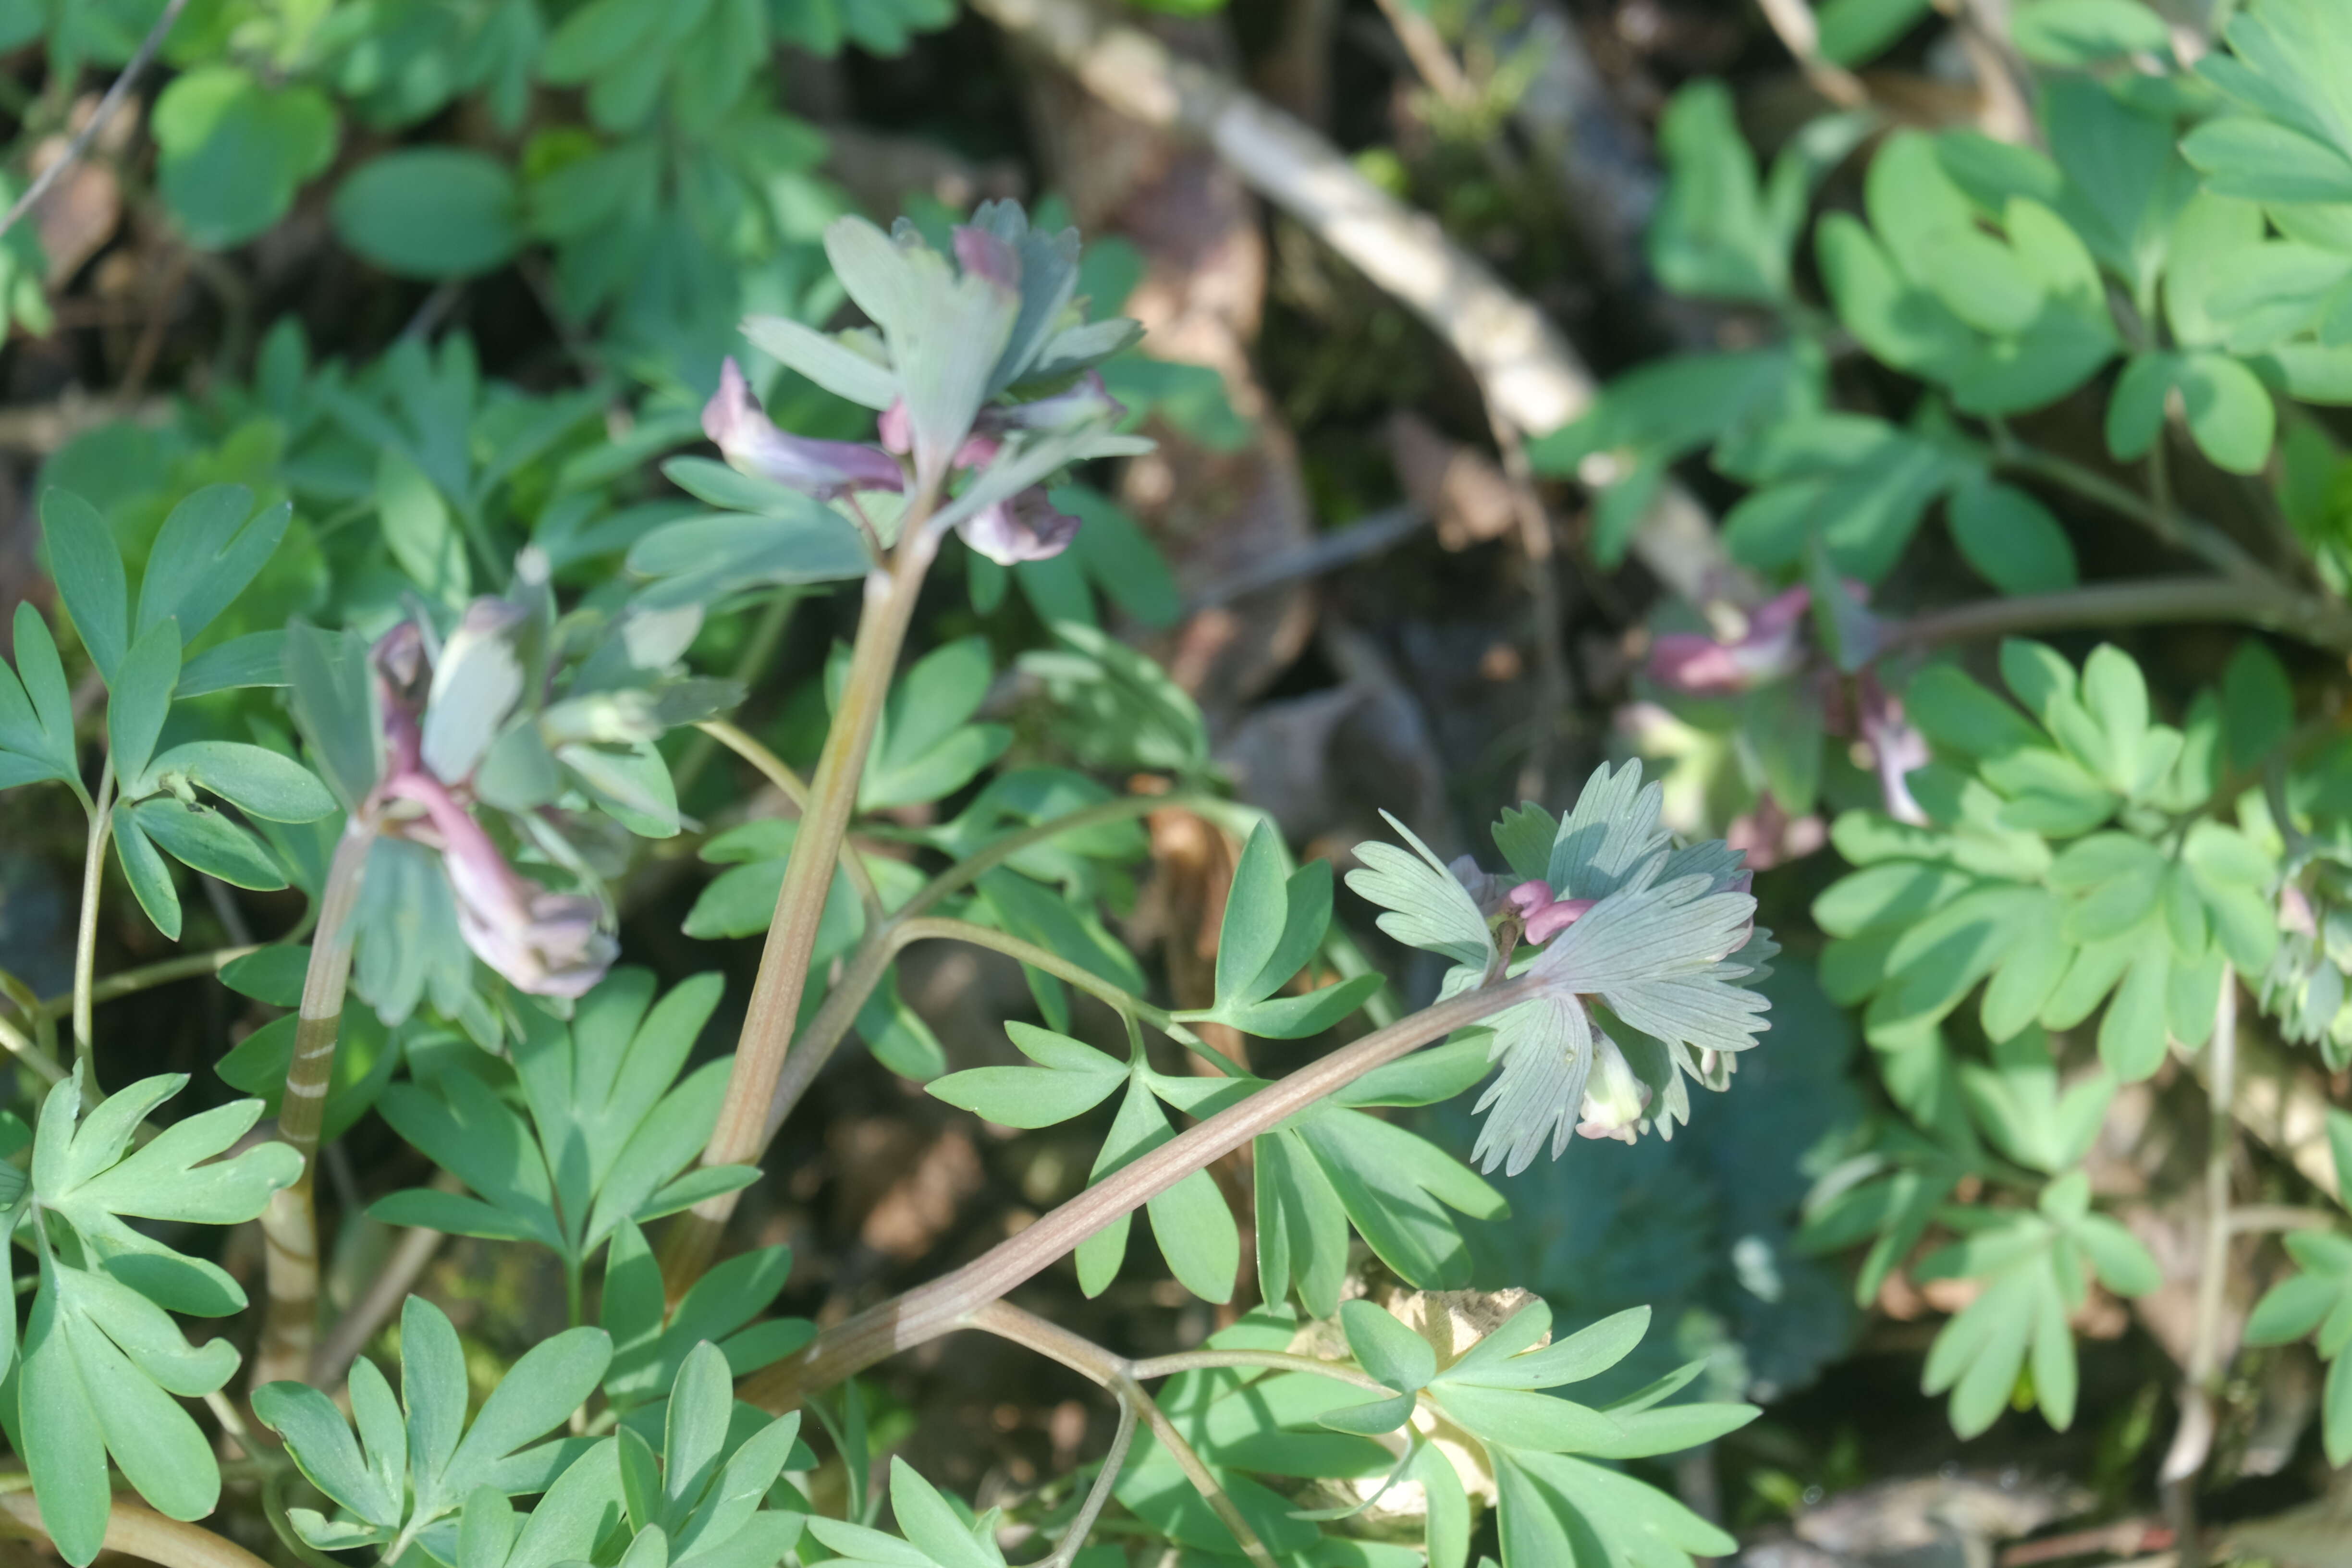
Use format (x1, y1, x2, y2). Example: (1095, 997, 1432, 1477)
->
(736, 976, 1541, 1413)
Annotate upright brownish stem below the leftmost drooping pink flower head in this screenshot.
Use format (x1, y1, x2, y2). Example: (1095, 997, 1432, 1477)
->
(252, 816, 376, 1387)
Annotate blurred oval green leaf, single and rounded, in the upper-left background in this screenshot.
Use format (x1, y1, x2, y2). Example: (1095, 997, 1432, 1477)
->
(331, 148, 522, 277)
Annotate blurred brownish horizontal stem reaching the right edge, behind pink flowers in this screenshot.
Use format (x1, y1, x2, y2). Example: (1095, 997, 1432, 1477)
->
(1879, 578, 2352, 653)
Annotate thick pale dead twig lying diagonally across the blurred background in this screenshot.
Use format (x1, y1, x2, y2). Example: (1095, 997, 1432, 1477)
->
(974, 0, 1733, 597)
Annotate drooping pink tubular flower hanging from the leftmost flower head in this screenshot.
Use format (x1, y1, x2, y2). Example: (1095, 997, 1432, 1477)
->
(386, 771, 621, 997)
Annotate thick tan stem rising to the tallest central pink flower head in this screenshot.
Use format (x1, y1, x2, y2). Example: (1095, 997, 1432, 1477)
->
(661, 522, 939, 1300)
